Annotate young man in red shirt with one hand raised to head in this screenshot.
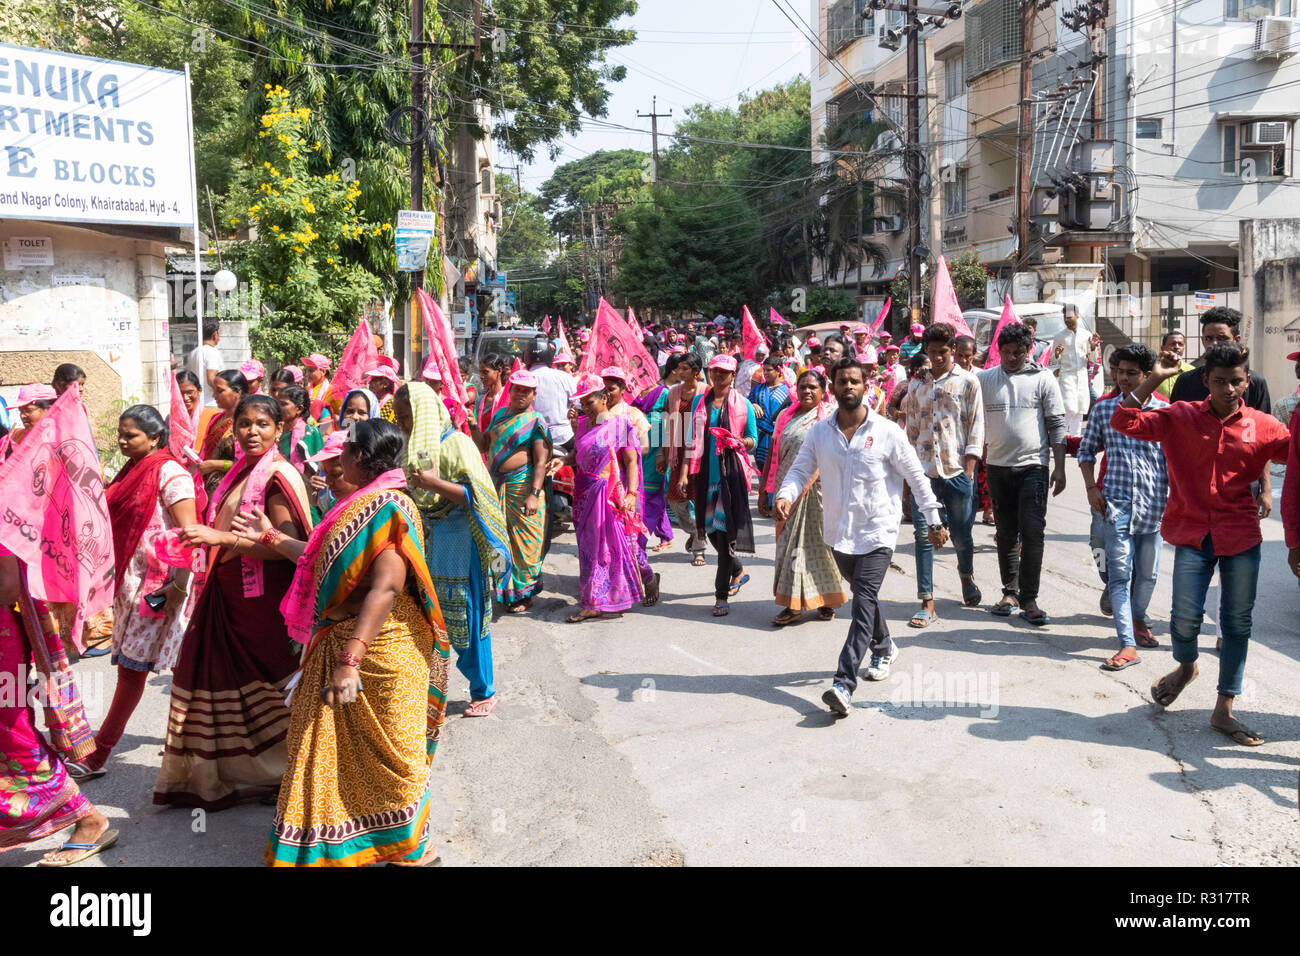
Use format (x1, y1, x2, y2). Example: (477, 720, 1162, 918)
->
(1110, 342, 1291, 747)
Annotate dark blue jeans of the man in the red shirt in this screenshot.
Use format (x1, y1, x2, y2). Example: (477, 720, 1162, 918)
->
(1169, 535, 1260, 697)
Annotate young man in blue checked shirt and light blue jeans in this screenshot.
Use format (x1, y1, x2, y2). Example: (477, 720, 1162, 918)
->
(1079, 345, 1169, 671)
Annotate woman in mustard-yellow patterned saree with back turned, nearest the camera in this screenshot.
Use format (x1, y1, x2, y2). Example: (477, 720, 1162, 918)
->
(235, 419, 450, 866)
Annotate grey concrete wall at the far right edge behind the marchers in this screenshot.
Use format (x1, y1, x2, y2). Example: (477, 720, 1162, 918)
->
(1239, 219, 1300, 401)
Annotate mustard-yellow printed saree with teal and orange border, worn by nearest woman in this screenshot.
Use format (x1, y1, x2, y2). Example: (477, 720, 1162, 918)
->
(265, 486, 450, 866)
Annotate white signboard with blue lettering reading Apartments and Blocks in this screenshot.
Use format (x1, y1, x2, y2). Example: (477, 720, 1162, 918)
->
(0, 44, 192, 226)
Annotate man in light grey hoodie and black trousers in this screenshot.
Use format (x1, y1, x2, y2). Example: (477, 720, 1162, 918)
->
(979, 323, 1065, 627)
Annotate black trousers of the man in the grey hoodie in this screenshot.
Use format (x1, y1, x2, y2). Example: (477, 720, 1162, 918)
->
(988, 464, 1048, 605)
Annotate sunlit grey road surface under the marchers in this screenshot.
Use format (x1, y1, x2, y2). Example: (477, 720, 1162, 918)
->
(0, 462, 1300, 866)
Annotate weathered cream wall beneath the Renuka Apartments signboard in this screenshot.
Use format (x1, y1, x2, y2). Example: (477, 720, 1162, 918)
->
(0, 220, 168, 418)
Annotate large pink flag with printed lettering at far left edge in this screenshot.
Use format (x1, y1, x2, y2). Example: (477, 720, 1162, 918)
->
(0, 382, 113, 649)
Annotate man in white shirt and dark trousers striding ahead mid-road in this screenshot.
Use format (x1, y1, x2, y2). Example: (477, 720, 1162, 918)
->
(774, 356, 948, 717)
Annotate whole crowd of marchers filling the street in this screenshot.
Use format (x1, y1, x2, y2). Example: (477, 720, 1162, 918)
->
(0, 308, 1300, 865)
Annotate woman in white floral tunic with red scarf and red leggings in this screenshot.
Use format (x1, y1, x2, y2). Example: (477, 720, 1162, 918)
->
(68, 405, 198, 779)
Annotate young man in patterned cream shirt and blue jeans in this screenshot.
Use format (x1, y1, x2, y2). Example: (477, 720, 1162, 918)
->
(902, 323, 984, 627)
